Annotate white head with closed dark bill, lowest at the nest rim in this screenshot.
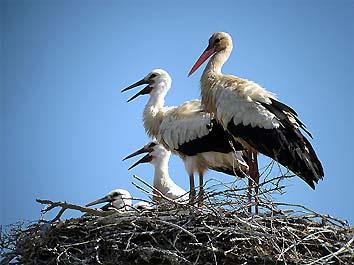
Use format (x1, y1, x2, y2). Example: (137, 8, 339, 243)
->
(86, 189, 132, 209)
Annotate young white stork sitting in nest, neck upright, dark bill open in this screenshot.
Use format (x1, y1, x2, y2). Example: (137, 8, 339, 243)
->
(123, 141, 188, 203)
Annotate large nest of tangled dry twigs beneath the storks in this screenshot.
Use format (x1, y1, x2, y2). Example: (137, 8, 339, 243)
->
(1, 171, 354, 265)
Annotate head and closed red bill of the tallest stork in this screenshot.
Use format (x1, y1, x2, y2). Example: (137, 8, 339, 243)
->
(188, 32, 232, 76)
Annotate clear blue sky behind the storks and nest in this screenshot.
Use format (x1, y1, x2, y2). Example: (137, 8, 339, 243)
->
(0, 0, 354, 224)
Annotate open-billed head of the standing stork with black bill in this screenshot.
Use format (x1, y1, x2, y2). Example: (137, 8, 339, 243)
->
(122, 69, 172, 102)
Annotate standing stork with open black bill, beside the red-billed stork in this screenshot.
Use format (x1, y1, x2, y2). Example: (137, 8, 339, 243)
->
(122, 69, 248, 205)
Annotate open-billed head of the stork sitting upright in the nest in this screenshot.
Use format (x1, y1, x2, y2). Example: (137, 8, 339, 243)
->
(123, 141, 171, 170)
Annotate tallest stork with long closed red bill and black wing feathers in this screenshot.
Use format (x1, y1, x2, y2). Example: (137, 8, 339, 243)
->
(188, 32, 324, 211)
